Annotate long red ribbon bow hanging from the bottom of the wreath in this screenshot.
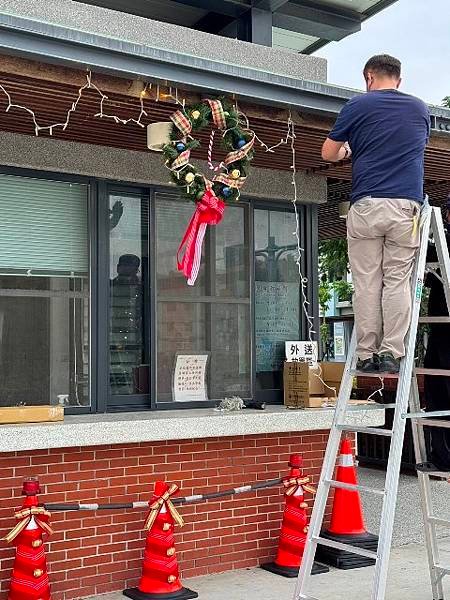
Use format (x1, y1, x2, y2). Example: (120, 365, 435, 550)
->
(177, 190, 225, 285)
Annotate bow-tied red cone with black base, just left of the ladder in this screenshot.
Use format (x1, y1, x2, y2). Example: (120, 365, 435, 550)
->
(261, 454, 329, 577)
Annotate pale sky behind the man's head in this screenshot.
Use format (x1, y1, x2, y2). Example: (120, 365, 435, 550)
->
(315, 0, 450, 104)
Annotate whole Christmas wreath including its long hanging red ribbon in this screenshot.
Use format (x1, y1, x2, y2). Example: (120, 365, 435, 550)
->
(163, 99, 255, 285)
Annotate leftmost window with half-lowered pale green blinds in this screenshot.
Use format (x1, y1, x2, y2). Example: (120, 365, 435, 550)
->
(0, 175, 90, 406)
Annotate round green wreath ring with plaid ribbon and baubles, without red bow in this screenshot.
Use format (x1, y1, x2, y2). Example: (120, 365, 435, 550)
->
(163, 99, 255, 202)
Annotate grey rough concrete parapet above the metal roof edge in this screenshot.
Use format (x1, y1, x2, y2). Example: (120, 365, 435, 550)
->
(0, 0, 327, 82)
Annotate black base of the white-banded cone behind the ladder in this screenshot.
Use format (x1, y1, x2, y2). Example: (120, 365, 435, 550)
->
(317, 531, 378, 570)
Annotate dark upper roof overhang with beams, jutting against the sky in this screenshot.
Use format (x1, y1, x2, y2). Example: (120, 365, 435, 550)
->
(77, 0, 397, 54)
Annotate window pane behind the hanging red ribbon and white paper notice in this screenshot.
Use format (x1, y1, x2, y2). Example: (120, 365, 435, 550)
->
(155, 193, 251, 403)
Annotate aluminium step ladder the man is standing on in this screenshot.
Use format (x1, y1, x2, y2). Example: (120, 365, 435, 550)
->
(294, 203, 450, 600)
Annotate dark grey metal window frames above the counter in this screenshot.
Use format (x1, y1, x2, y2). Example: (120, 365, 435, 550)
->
(0, 166, 319, 415)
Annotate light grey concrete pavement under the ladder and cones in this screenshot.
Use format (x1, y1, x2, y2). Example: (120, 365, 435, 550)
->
(88, 468, 450, 600)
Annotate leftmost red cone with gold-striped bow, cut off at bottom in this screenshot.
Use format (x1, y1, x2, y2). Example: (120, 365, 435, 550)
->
(5, 479, 52, 600)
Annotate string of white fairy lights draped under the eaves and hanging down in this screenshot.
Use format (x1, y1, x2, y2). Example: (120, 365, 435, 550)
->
(0, 71, 372, 398)
